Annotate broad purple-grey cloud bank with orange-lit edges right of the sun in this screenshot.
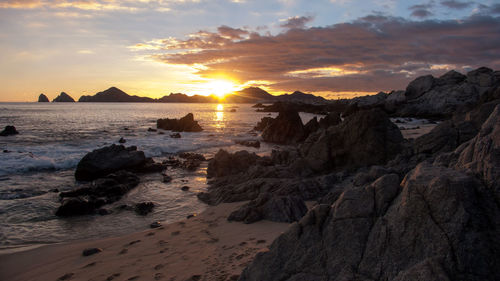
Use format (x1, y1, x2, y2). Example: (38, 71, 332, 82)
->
(140, 15, 500, 92)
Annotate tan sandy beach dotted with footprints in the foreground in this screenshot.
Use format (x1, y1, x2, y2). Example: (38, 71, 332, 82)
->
(0, 202, 289, 281)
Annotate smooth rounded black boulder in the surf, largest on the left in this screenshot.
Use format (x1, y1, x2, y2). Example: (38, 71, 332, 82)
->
(75, 144, 146, 181)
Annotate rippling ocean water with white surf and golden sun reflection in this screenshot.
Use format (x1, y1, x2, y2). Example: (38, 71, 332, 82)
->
(0, 103, 314, 251)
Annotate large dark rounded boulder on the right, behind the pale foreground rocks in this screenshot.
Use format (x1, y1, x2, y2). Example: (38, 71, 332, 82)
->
(299, 109, 404, 172)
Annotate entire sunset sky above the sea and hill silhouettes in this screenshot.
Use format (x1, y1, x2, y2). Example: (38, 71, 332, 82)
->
(0, 0, 500, 101)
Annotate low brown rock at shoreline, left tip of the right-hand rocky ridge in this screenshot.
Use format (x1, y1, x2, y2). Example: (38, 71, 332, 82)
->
(207, 149, 259, 178)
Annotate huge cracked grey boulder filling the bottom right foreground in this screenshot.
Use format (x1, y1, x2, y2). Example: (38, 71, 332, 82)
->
(239, 163, 500, 281)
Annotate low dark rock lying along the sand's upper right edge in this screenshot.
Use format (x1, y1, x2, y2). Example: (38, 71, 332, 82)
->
(227, 193, 307, 223)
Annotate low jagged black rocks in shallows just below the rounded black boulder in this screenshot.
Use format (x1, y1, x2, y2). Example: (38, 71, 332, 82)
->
(56, 171, 139, 217)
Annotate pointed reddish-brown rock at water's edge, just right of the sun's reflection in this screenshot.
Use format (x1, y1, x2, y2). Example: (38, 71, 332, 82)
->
(262, 111, 305, 144)
